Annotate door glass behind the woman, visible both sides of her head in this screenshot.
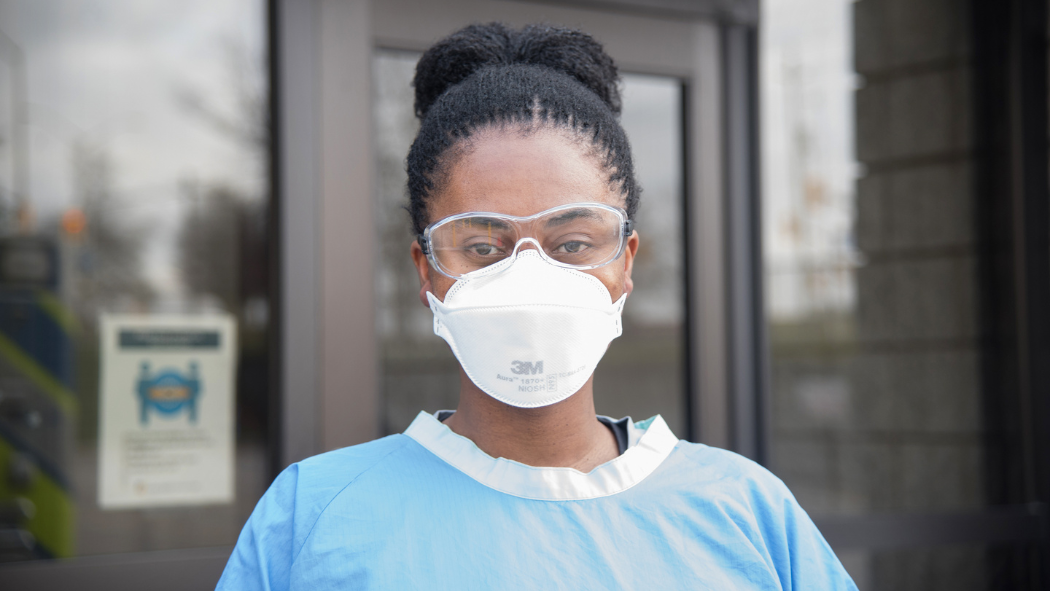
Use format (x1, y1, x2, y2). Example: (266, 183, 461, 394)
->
(373, 51, 686, 436)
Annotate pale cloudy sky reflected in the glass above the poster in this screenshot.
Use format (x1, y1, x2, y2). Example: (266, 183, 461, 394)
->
(0, 0, 265, 291)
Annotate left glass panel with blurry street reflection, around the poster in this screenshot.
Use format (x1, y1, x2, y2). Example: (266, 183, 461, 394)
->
(0, 0, 270, 561)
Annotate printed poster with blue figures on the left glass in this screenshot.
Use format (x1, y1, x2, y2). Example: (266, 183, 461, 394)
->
(99, 315, 236, 509)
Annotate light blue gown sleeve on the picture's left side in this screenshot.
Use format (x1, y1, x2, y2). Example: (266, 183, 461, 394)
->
(215, 464, 298, 591)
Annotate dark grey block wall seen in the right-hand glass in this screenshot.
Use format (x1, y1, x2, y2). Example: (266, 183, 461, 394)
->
(843, 0, 985, 589)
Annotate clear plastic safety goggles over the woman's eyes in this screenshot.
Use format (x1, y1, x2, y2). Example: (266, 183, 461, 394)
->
(417, 203, 633, 279)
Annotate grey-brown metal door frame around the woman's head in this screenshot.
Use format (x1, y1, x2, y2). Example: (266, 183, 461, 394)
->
(0, 0, 739, 590)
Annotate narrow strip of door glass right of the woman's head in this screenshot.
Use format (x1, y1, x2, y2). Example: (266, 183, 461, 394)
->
(594, 75, 688, 438)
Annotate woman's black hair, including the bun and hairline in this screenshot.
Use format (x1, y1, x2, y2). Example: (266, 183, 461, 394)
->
(407, 23, 641, 234)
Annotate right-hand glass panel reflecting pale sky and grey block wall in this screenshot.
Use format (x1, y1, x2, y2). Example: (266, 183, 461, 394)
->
(761, 0, 992, 589)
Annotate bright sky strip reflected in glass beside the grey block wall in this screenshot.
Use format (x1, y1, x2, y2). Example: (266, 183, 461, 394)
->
(760, 0, 859, 319)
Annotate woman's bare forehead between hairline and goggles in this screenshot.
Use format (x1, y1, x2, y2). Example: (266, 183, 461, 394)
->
(427, 129, 624, 223)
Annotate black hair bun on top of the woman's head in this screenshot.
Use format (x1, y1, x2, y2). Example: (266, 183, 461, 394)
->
(413, 22, 621, 119)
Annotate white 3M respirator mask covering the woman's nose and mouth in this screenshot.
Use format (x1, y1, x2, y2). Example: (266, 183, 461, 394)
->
(426, 250, 627, 408)
